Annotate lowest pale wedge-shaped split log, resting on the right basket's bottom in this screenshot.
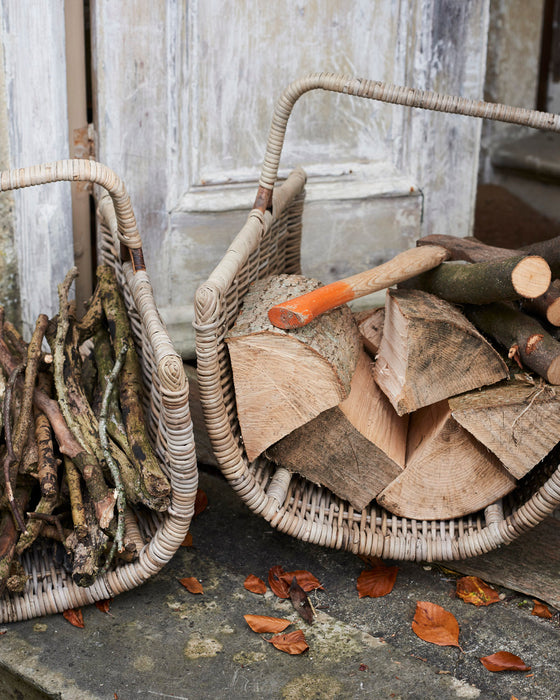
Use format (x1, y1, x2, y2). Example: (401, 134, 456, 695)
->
(377, 400, 516, 520)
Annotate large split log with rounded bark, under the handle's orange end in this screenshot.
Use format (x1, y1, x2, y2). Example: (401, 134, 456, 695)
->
(226, 275, 361, 461)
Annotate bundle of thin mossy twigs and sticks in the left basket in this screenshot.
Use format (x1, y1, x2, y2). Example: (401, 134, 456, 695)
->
(0, 266, 170, 593)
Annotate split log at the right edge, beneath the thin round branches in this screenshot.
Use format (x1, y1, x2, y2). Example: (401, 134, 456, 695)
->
(449, 379, 560, 479)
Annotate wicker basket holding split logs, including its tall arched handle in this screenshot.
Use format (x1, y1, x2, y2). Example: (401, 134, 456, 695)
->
(195, 73, 560, 561)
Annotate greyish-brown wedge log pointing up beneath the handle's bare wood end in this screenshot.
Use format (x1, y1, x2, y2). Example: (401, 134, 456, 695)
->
(374, 289, 508, 415)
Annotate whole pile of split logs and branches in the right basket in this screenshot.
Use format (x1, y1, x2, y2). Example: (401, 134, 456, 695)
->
(226, 236, 560, 520)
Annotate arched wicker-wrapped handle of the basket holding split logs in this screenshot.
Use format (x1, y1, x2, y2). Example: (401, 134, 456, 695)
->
(253, 73, 560, 212)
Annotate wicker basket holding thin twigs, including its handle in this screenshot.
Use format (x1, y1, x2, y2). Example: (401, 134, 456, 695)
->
(0, 160, 198, 622)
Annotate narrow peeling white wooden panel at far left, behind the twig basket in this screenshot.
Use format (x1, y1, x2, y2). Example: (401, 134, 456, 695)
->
(0, 0, 73, 338)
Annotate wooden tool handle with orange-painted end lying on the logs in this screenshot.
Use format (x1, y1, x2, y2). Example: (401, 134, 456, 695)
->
(268, 246, 449, 330)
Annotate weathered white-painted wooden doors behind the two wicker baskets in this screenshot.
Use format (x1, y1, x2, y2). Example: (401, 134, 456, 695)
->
(0, 0, 489, 357)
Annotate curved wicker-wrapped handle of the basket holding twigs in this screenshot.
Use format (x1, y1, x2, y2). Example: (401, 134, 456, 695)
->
(0, 158, 146, 272)
